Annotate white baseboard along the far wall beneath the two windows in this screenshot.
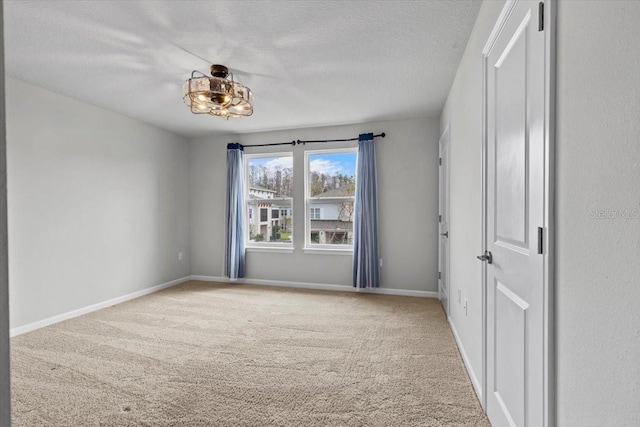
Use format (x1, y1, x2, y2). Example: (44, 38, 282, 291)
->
(190, 276, 438, 298)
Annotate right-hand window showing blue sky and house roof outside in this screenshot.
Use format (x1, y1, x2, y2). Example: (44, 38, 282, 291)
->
(305, 149, 357, 249)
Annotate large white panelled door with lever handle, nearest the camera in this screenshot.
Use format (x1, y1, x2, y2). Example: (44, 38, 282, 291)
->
(484, 1, 545, 427)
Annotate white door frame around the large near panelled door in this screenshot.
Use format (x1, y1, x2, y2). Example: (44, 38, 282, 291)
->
(481, 0, 557, 427)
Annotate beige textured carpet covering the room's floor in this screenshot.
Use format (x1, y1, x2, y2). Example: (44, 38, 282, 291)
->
(11, 282, 489, 427)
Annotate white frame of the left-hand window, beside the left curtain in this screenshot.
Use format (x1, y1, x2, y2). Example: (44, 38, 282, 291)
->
(243, 151, 295, 252)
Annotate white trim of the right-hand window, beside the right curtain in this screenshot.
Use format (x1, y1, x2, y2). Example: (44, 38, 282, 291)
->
(302, 147, 358, 255)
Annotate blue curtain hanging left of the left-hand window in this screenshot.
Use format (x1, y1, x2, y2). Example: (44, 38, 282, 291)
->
(224, 144, 245, 279)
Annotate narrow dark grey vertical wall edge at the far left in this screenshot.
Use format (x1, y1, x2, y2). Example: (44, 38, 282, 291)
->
(0, 3, 11, 427)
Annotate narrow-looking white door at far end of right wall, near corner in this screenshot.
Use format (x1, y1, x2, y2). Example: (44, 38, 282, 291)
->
(438, 126, 451, 315)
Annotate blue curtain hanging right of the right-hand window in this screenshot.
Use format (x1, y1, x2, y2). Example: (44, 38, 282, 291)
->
(353, 133, 380, 288)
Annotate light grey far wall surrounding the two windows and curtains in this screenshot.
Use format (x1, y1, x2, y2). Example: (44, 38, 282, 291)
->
(190, 119, 438, 292)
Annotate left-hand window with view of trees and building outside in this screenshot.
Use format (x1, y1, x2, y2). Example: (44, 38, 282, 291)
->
(245, 153, 293, 246)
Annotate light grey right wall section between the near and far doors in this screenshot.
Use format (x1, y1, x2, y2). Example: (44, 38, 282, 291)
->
(440, 1, 504, 393)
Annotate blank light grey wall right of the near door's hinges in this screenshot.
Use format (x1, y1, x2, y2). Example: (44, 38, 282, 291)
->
(556, 0, 640, 427)
